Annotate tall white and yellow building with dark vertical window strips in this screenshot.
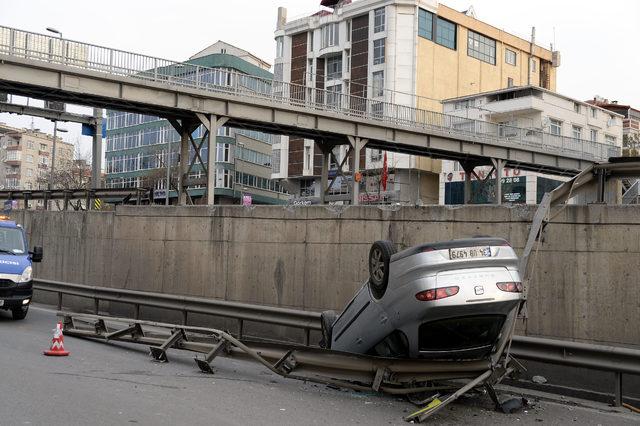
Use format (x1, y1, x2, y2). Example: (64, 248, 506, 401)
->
(272, 0, 559, 204)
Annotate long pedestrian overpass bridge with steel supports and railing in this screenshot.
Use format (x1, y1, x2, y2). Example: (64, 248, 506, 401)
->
(0, 26, 619, 204)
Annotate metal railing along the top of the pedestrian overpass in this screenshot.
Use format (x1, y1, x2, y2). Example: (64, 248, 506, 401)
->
(0, 26, 620, 162)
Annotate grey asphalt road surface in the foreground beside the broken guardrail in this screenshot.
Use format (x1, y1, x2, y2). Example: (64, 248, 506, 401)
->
(0, 307, 640, 426)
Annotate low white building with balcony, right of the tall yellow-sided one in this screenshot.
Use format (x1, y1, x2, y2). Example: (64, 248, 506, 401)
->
(440, 86, 625, 204)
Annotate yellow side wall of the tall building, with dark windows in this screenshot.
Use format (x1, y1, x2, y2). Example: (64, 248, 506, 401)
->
(416, 4, 559, 111)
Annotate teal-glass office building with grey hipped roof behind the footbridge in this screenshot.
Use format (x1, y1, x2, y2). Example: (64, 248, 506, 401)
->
(105, 41, 289, 204)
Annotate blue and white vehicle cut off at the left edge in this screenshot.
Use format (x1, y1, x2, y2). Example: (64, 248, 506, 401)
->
(0, 216, 42, 320)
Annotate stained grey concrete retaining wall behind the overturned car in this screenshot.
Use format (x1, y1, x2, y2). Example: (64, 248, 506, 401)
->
(14, 205, 640, 345)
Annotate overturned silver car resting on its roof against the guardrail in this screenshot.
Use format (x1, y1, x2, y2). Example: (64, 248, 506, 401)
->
(321, 237, 523, 359)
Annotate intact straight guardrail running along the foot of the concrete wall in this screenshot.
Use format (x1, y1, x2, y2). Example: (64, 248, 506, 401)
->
(33, 279, 640, 406)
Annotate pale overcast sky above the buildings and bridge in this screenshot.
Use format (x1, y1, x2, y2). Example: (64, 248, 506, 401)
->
(0, 0, 640, 156)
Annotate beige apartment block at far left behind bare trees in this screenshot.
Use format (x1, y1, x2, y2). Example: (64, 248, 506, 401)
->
(0, 124, 75, 190)
